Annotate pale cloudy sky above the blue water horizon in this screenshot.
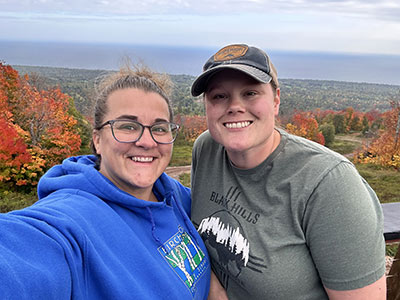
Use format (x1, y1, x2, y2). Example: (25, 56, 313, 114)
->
(0, 0, 400, 55)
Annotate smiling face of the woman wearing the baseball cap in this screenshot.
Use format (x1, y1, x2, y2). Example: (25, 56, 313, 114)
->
(205, 70, 280, 167)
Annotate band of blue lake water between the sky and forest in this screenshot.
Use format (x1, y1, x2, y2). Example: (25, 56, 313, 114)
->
(0, 41, 400, 85)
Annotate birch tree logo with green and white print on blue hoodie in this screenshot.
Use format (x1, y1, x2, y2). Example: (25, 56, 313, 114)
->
(158, 227, 209, 295)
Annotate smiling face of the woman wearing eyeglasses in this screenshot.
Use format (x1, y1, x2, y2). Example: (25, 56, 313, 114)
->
(93, 88, 173, 200)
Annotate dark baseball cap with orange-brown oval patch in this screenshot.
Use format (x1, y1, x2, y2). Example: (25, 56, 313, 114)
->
(191, 44, 279, 96)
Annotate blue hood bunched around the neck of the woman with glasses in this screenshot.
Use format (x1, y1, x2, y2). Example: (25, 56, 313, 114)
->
(38, 155, 196, 244)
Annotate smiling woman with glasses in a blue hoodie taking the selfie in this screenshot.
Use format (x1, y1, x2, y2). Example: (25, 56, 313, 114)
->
(0, 65, 210, 300)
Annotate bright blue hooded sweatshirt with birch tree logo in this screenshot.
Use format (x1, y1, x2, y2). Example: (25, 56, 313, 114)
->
(0, 156, 210, 300)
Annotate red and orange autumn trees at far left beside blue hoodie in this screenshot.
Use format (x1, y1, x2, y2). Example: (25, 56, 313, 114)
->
(0, 62, 81, 186)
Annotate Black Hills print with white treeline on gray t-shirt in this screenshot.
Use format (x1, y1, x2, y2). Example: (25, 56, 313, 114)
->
(198, 187, 266, 288)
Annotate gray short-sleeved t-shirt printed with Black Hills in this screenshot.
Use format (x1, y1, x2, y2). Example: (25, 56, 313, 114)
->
(192, 130, 385, 300)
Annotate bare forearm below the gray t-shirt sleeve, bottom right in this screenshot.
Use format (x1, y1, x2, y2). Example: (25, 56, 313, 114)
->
(325, 275, 386, 300)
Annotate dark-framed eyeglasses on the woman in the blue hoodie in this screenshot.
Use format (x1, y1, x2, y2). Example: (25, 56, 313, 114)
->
(96, 120, 179, 144)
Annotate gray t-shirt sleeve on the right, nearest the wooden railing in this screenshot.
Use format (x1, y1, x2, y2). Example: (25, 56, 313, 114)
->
(303, 162, 385, 290)
